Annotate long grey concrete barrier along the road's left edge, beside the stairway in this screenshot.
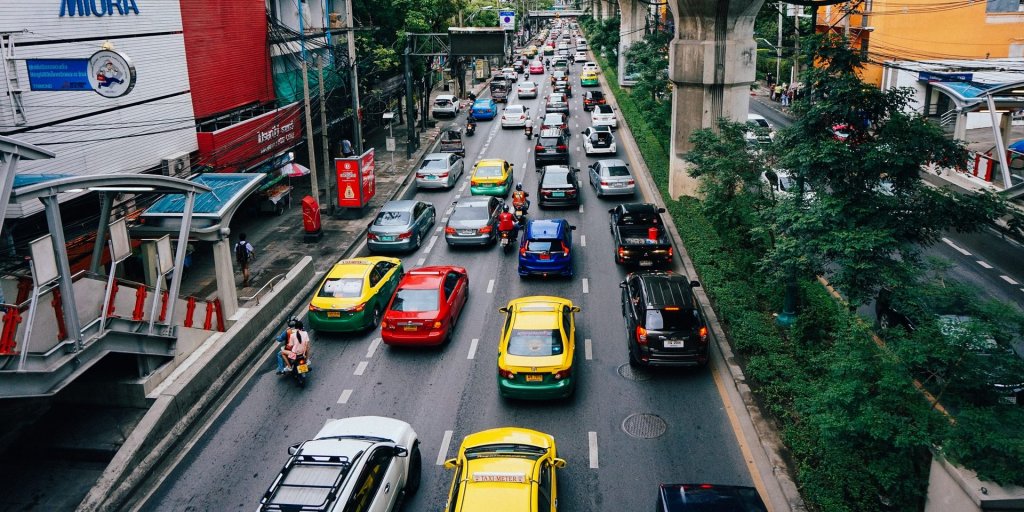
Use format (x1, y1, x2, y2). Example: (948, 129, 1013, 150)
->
(77, 256, 316, 511)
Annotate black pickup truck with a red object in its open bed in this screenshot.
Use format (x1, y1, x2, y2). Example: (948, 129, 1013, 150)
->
(608, 203, 673, 267)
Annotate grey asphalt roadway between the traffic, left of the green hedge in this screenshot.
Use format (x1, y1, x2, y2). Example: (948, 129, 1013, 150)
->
(144, 60, 754, 511)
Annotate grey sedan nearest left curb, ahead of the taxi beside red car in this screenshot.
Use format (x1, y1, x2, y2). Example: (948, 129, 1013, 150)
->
(367, 201, 437, 253)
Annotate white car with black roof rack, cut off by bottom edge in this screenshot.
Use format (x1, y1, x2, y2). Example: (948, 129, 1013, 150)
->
(259, 416, 423, 512)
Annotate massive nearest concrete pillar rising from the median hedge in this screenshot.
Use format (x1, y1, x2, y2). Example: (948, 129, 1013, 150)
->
(669, 0, 763, 199)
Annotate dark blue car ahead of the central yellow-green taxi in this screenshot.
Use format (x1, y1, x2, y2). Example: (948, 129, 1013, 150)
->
(519, 219, 575, 278)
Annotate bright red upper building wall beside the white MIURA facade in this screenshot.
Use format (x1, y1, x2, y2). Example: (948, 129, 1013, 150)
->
(180, 0, 274, 119)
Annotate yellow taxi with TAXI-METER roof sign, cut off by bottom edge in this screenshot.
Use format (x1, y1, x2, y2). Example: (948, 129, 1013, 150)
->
(444, 427, 565, 512)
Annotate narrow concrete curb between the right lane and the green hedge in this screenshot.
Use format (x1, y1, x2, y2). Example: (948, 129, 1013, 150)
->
(598, 73, 807, 512)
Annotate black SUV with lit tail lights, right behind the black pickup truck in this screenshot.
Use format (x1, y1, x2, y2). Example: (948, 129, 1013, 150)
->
(618, 271, 709, 367)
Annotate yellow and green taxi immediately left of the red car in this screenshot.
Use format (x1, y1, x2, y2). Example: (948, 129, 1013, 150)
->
(307, 256, 406, 332)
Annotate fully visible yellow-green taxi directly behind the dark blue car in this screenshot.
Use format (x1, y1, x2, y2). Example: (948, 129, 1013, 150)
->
(498, 295, 580, 399)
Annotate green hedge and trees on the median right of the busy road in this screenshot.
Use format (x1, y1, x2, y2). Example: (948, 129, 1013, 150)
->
(583, 20, 1024, 511)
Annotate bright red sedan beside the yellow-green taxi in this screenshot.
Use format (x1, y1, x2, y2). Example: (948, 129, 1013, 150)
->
(381, 266, 469, 346)
